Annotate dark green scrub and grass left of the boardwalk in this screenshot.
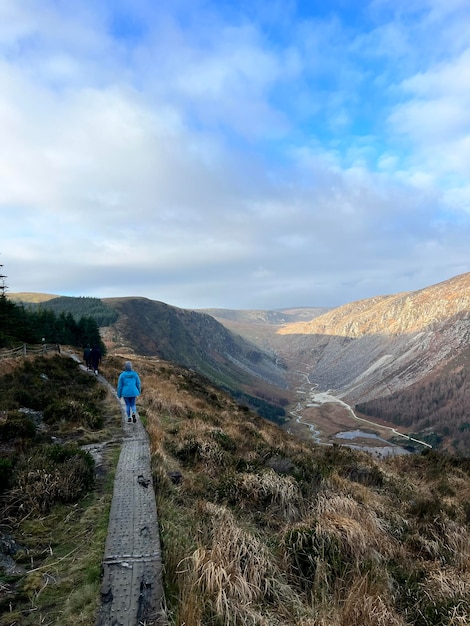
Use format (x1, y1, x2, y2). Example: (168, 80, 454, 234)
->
(0, 355, 120, 626)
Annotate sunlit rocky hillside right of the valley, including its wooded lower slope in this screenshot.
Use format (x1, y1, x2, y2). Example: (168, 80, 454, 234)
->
(200, 274, 470, 455)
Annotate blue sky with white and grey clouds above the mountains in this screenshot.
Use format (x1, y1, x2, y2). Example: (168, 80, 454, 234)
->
(0, 0, 470, 309)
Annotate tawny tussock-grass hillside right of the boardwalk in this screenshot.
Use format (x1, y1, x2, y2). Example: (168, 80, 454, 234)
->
(104, 357, 470, 626)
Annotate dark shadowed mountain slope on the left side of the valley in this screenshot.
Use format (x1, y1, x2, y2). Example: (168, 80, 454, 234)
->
(103, 298, 289, 421)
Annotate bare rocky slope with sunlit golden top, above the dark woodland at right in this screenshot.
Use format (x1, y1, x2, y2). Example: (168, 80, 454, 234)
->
(278, 273, 470, 403)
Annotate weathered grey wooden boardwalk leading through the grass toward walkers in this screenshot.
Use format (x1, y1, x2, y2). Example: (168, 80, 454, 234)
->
(96, 376, 167, 626)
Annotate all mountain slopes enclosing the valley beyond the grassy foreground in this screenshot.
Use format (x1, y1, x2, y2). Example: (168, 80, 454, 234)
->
(10, 273, 470, 454)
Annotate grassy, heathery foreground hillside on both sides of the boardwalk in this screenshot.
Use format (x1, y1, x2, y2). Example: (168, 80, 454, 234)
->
(0, 314, 470, 626)
